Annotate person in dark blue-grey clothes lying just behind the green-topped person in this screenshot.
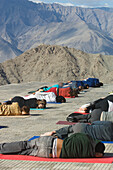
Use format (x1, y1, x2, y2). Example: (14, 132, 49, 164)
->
(52, 121, 113, 141)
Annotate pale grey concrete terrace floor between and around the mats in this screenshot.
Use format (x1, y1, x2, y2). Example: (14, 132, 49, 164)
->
(0, 82, 113, 170)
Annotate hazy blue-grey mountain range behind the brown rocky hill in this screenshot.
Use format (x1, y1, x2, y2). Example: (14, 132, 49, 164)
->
(0, 0, 113, 62)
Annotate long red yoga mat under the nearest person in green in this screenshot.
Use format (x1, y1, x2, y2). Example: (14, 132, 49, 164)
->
(0, 154, 113, 163)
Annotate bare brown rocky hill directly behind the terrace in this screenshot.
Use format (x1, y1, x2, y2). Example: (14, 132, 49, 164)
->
(0, 45, 113, 85)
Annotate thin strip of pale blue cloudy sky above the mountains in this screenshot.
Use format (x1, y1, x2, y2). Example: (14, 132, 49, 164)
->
(30, 0, 113, 8)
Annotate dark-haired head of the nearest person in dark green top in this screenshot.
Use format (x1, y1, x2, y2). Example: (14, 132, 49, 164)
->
(95, 142, 105, 158)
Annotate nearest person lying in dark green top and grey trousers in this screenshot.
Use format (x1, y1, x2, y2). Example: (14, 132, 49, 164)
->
(0, 133, 105, 158)
